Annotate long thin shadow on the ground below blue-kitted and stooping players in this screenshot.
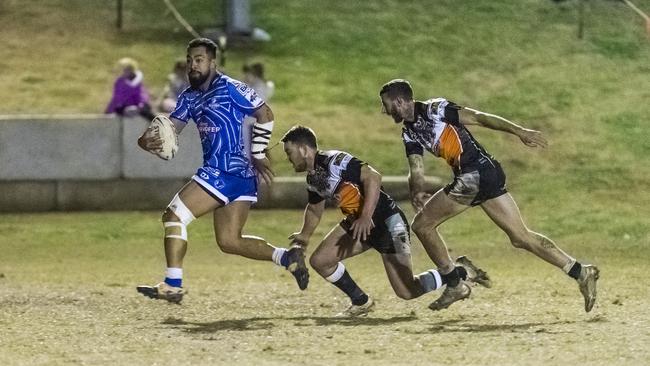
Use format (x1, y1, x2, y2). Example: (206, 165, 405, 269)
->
(161, 316, 418, 333)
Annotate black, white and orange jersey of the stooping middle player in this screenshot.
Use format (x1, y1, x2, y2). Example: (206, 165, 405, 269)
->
(307, 150, 397, 222)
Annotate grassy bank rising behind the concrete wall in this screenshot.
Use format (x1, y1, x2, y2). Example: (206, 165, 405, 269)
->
(0, 0, 650, 176)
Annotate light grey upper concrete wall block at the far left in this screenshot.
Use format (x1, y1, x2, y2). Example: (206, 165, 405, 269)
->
(0, 114, 121, 181)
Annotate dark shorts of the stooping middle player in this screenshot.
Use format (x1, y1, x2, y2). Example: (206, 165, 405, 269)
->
(339, 210, 411, 254)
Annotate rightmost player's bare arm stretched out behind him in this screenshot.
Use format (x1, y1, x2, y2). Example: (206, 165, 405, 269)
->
(458, 108, 548, 147)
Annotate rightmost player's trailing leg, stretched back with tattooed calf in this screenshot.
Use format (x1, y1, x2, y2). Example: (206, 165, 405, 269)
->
(481, 193, 599, 311)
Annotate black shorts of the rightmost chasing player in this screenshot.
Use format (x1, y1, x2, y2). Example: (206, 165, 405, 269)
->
(444, 157, 508, 206)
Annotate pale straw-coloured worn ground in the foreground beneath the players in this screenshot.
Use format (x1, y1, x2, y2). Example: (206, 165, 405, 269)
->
(0, 256, 650, 365)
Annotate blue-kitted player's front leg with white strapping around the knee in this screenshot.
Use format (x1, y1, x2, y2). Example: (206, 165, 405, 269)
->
(137, 181, 220, 303)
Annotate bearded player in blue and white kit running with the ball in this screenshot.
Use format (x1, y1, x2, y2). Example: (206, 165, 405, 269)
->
(137, 38, 309, 303)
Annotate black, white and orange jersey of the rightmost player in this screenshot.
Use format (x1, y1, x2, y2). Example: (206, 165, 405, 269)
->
(402, 98, 492, 174)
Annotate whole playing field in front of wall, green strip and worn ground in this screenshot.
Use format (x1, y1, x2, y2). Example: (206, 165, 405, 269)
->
(0, 210, 650, 365)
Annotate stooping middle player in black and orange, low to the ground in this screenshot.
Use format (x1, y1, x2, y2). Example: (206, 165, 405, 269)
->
(281, 126, 490, 316)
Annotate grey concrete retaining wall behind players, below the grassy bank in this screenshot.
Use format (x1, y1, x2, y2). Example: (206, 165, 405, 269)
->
(0, 115, 441, 212)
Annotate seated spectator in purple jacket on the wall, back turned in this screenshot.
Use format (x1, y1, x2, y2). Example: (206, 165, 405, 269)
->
(105, 57, 154, 120)
